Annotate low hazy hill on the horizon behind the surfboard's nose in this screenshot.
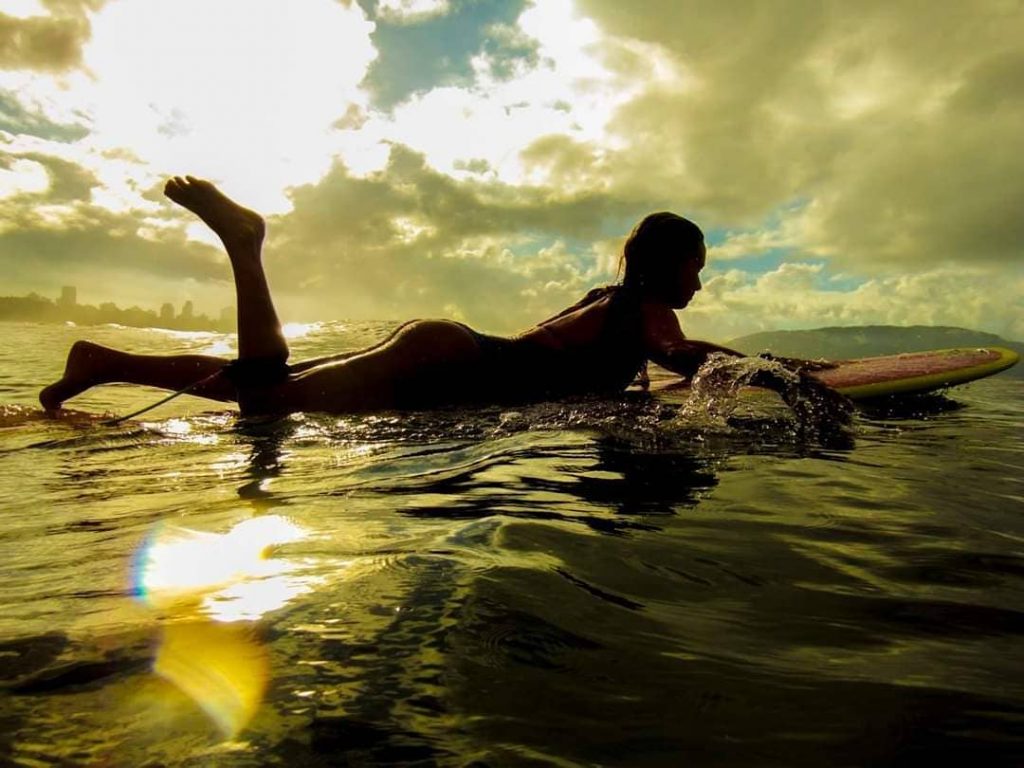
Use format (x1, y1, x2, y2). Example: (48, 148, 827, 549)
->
(728, 326, 1024, 378)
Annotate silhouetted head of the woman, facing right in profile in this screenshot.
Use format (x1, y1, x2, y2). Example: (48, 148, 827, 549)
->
(621, 211, 706, 307)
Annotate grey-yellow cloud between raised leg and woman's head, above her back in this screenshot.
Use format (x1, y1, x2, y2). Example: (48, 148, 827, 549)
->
(267, 144, 629, 331)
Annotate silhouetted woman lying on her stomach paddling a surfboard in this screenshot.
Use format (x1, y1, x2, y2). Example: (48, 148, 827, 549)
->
(39, 176, 839, 415)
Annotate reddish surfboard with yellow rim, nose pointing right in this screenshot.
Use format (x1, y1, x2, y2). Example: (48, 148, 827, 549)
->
(651, 347, 1020, 400)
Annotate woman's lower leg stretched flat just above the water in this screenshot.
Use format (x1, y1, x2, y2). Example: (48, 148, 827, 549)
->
(39, 341, 236, 411)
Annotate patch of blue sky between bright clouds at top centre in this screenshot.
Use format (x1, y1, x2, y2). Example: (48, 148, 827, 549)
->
(360, 0, 537, 109)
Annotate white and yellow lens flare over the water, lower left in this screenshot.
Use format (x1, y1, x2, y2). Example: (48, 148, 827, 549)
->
(133, 515, 315, 738)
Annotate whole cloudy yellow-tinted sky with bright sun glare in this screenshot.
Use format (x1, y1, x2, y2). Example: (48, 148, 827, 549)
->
(0, 0, 1024, 340)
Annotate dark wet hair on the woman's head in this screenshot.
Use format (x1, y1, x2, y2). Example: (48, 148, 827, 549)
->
(618, 211, 703, 288)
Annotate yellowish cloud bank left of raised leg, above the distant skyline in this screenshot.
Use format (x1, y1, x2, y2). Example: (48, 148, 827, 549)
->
(0, 142, 230, 308)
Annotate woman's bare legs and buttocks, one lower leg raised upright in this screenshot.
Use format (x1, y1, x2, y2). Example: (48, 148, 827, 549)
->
(40, 176, 480, 414)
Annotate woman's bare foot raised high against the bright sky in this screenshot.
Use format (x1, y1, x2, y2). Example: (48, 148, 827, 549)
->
(164, 176, 266, 259)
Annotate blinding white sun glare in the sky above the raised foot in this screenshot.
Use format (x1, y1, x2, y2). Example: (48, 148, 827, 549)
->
(79, 0, 376, 213)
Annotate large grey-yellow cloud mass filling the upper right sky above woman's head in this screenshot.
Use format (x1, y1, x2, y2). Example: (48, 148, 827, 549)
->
(561, 0, 1024, 273)
